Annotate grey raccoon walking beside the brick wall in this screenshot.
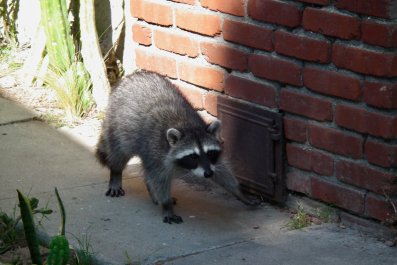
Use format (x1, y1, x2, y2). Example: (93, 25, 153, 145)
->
(96, 71, 257, 224)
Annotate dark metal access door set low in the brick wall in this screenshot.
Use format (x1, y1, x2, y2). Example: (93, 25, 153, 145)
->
(218, 97, 286, 203)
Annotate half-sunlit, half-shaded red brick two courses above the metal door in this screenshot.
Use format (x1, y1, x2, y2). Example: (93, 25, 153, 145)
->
(200, 42, 248, 71)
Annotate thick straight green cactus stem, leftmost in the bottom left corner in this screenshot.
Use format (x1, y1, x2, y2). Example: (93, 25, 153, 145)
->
(17, 190, 43, 265)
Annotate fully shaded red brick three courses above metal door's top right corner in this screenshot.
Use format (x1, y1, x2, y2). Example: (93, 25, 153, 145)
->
(274, 30, 331, 63)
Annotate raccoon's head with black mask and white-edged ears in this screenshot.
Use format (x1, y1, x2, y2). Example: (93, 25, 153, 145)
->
(167, 121, 222, 178)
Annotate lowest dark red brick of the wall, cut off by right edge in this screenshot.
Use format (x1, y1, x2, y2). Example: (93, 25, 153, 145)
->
(365, 194, 397, 221)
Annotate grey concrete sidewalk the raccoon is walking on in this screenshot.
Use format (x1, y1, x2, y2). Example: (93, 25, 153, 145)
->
(0, 98, 397, 265)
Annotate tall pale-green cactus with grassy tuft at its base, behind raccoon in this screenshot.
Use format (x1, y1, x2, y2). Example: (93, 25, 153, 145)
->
(40, 0, 93, 120)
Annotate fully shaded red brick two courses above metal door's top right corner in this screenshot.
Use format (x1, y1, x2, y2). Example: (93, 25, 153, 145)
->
(248, 54, 302, 86)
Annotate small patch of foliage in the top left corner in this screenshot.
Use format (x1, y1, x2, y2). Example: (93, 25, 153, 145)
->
(0, 0, 19, 43)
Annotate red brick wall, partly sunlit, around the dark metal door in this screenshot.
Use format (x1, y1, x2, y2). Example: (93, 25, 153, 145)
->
(129, 0, 397, 223)
